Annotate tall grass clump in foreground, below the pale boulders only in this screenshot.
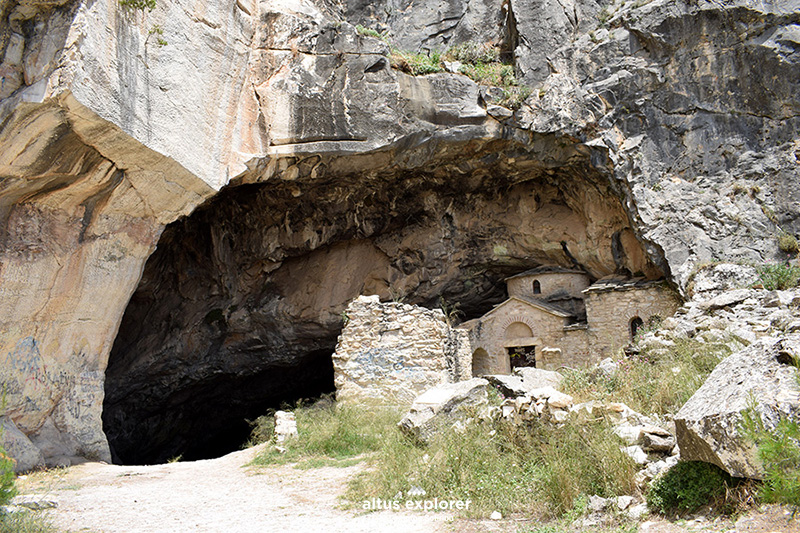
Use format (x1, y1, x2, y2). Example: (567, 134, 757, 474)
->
(347, 414, 636, 516)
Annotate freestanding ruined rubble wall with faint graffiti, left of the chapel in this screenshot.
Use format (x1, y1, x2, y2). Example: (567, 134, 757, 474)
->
(333, 296, 472, 404)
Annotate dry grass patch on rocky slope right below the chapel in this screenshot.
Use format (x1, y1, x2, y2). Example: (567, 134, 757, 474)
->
(562, 339, 730, 414)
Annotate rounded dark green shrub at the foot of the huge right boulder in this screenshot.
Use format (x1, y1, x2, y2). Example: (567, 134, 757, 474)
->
(647, 461, 734, 515)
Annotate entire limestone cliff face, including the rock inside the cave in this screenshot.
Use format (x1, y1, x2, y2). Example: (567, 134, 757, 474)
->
(0, 0, 800, 463)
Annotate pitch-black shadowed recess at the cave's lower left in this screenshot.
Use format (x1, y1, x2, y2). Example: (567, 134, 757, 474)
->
(103, 350, 335, 465)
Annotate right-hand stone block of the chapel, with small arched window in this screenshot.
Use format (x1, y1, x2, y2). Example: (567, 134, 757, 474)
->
(586, 284, 680, 359)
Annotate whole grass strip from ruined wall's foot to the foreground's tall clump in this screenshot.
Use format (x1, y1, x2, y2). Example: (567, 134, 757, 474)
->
(253, 394, 637, 516)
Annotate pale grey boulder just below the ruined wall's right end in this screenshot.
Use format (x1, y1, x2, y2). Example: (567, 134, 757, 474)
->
(398, 378, 489, 444)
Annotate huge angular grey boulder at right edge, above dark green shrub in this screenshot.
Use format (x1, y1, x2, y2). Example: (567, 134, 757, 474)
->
(675, 334, 800, 479)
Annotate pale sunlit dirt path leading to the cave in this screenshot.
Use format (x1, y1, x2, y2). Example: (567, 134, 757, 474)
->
(20, 447, 462, 533)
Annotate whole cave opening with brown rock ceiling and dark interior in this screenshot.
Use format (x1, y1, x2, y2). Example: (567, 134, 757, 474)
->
(103, 135, 663, 464)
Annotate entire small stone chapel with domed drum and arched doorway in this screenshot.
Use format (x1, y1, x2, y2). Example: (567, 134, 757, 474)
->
(459, 267, 680, 376)
